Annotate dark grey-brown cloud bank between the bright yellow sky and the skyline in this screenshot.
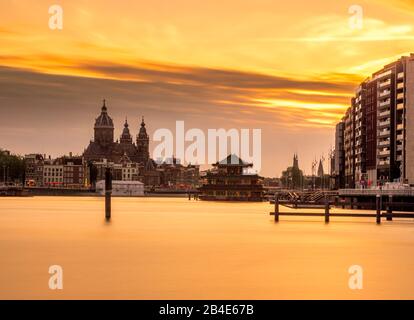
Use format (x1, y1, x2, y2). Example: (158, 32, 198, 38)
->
(0, 63, 353, 175)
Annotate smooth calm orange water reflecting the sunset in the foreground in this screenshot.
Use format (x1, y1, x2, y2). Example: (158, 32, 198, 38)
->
(0, 197, 414, 299)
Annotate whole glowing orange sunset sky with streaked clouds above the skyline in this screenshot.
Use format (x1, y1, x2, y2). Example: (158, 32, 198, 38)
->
(0, 0, 414, 176)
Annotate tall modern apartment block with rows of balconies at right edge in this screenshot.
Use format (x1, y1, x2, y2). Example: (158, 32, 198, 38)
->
(336, 54, 414, 188)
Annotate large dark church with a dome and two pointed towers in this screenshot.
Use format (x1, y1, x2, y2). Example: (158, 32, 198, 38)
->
(83, 100, 152, 166)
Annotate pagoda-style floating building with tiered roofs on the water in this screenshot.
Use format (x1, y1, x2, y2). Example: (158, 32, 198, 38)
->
(199, 154, 263, 201)
